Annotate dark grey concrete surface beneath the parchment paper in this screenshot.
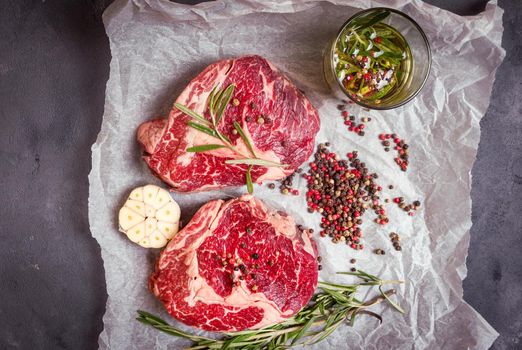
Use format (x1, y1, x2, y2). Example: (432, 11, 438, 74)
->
(0, 0, 522, 349)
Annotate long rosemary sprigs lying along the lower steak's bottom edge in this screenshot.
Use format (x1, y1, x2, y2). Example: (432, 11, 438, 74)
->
(137, 270, 404, 350)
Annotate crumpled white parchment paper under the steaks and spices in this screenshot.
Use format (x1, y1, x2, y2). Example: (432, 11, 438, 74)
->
(89, 0, 504, 349)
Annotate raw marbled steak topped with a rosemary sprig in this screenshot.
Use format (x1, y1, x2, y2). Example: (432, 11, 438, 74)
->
(138, 56, 319, 192)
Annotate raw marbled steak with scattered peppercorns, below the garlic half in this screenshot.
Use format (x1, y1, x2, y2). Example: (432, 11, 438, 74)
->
(150, 195, 317, 331)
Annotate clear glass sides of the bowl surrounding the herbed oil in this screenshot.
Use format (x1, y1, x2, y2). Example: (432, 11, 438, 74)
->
(324, 7, 431, 110)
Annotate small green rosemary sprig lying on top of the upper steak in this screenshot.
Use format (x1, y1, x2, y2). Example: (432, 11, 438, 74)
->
(174, 84, 287, 194)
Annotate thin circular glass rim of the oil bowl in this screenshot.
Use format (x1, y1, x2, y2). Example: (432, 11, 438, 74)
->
(329, 7, 432, 110)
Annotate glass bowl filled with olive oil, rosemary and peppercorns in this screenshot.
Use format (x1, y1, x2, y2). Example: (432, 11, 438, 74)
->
(325, 8, 431, 109)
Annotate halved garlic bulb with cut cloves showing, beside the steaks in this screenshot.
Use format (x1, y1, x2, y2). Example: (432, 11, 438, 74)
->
(118, 185, 181, 248)
